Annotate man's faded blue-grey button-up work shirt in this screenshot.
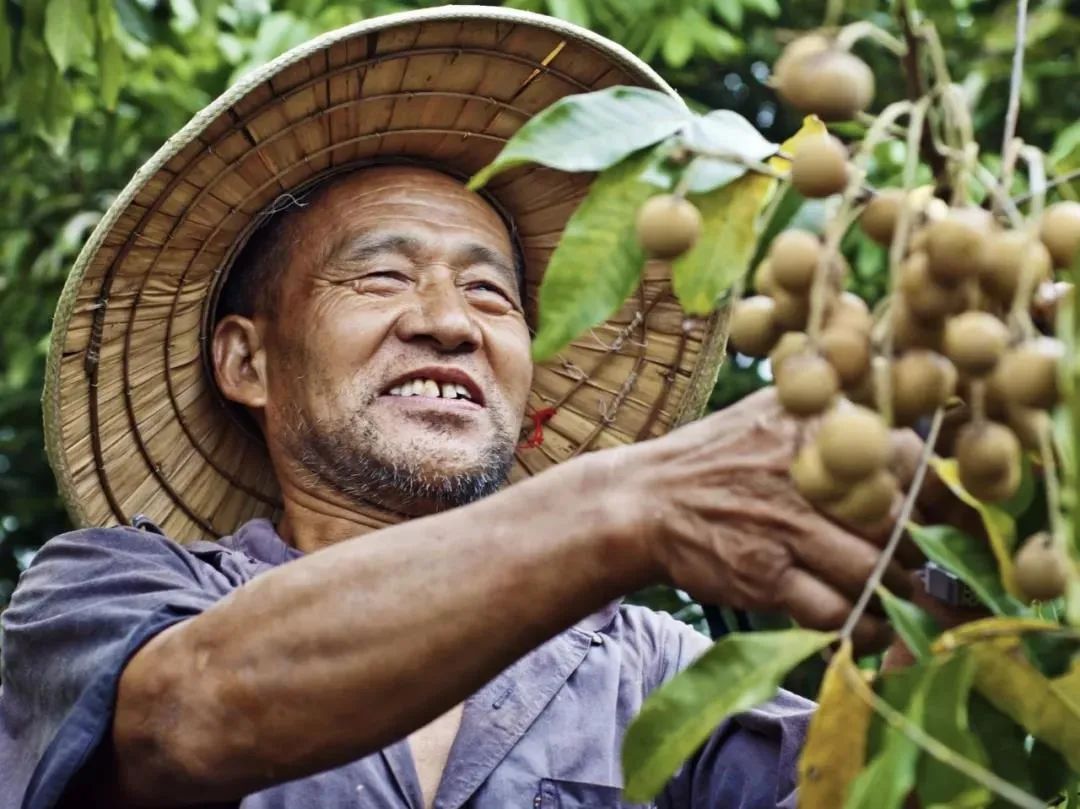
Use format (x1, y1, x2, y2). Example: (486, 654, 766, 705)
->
(0, 520, 813, 809)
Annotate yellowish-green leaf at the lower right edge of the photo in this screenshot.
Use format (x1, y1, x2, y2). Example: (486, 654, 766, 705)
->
(969, 637, 1080, 770)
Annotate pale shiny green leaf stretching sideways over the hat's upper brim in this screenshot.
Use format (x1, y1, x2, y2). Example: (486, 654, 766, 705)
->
(469, 86, 690, 190)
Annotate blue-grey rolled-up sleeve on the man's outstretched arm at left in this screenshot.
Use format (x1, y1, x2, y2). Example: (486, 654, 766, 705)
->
(0, 528, 234, 809)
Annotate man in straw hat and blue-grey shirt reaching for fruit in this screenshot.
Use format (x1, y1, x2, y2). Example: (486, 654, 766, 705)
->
(0, 9, 928, 809)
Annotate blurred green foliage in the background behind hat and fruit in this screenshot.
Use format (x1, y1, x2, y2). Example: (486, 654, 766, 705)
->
(0, 0, 1080, 623)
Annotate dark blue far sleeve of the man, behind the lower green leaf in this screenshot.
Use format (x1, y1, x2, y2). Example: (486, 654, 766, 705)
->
(658, 613, 815, 809)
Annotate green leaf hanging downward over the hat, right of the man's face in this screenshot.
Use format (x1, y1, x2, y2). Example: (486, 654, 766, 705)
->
(532, 152, 656, 362)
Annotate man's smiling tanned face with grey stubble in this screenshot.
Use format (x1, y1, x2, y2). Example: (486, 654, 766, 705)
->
(221, 166, 532, 511)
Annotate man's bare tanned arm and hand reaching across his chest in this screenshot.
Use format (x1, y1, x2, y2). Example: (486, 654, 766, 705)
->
(105, 393, 904, 806)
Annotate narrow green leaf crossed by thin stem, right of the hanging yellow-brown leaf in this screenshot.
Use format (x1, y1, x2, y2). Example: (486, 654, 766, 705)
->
(916, 653, 990, 807)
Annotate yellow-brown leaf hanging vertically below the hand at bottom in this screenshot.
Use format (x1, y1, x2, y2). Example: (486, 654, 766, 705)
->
(798, 641, 872, 809)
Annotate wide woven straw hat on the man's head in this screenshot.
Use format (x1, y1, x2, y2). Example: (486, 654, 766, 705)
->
(44, 5, 723, 540)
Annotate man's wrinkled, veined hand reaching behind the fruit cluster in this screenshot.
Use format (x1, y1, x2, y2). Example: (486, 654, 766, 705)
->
(635, 388, 921, 648)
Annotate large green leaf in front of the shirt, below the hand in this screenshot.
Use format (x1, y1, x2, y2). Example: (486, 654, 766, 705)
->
(622, 629, 836, 803)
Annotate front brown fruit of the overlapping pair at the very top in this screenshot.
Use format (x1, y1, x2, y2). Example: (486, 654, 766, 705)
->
(778, 49, 874, 121)
